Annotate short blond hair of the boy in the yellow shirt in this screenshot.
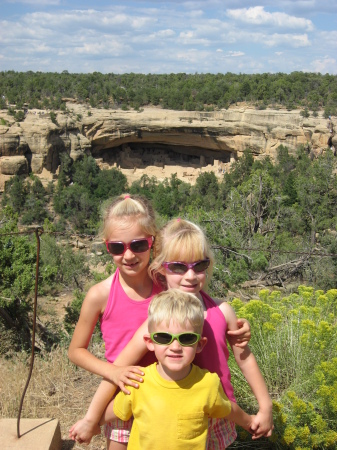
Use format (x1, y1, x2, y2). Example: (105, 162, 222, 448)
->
(148, 289, 204, 334)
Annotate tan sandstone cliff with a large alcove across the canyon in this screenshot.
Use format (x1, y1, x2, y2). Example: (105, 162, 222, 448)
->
(0, 103, 337, 186)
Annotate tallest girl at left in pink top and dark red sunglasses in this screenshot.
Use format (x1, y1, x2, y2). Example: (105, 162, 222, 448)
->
(68, 194, 161, 450)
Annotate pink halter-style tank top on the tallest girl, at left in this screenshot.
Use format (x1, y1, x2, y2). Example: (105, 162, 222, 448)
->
(100, 269, 162, 367)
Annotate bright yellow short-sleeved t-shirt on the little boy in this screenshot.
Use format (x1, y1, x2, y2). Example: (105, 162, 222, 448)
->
(113, 363, 231, 450)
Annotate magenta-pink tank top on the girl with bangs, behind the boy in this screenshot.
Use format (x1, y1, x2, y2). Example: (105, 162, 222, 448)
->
(194, 291, 235, 402)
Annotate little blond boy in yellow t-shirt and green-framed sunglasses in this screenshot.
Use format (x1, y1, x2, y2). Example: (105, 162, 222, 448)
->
(109, 289, 253, 450)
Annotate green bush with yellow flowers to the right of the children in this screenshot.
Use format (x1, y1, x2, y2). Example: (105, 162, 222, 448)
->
(229, 286, 337, 450)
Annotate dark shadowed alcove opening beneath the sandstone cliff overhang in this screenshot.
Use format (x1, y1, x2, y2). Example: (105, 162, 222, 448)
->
(95, 142, 230, 169)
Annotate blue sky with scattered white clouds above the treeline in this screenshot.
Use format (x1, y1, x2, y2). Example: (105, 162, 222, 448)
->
(0, 0, 337, 74)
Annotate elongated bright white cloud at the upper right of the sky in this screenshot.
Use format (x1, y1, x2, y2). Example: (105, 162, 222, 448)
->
(227, 6, 314, 31)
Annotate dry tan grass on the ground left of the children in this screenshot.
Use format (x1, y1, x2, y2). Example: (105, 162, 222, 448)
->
(0, 348, 106, 450)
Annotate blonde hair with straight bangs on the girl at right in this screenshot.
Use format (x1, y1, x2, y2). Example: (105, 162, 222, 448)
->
(149, 219, 214, 286)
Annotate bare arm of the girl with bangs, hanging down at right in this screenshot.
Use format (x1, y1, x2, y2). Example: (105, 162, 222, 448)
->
(220, 303, 274, 439)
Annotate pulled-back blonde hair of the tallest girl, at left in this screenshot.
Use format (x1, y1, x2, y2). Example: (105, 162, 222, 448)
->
(101, 194, 157, 240)
